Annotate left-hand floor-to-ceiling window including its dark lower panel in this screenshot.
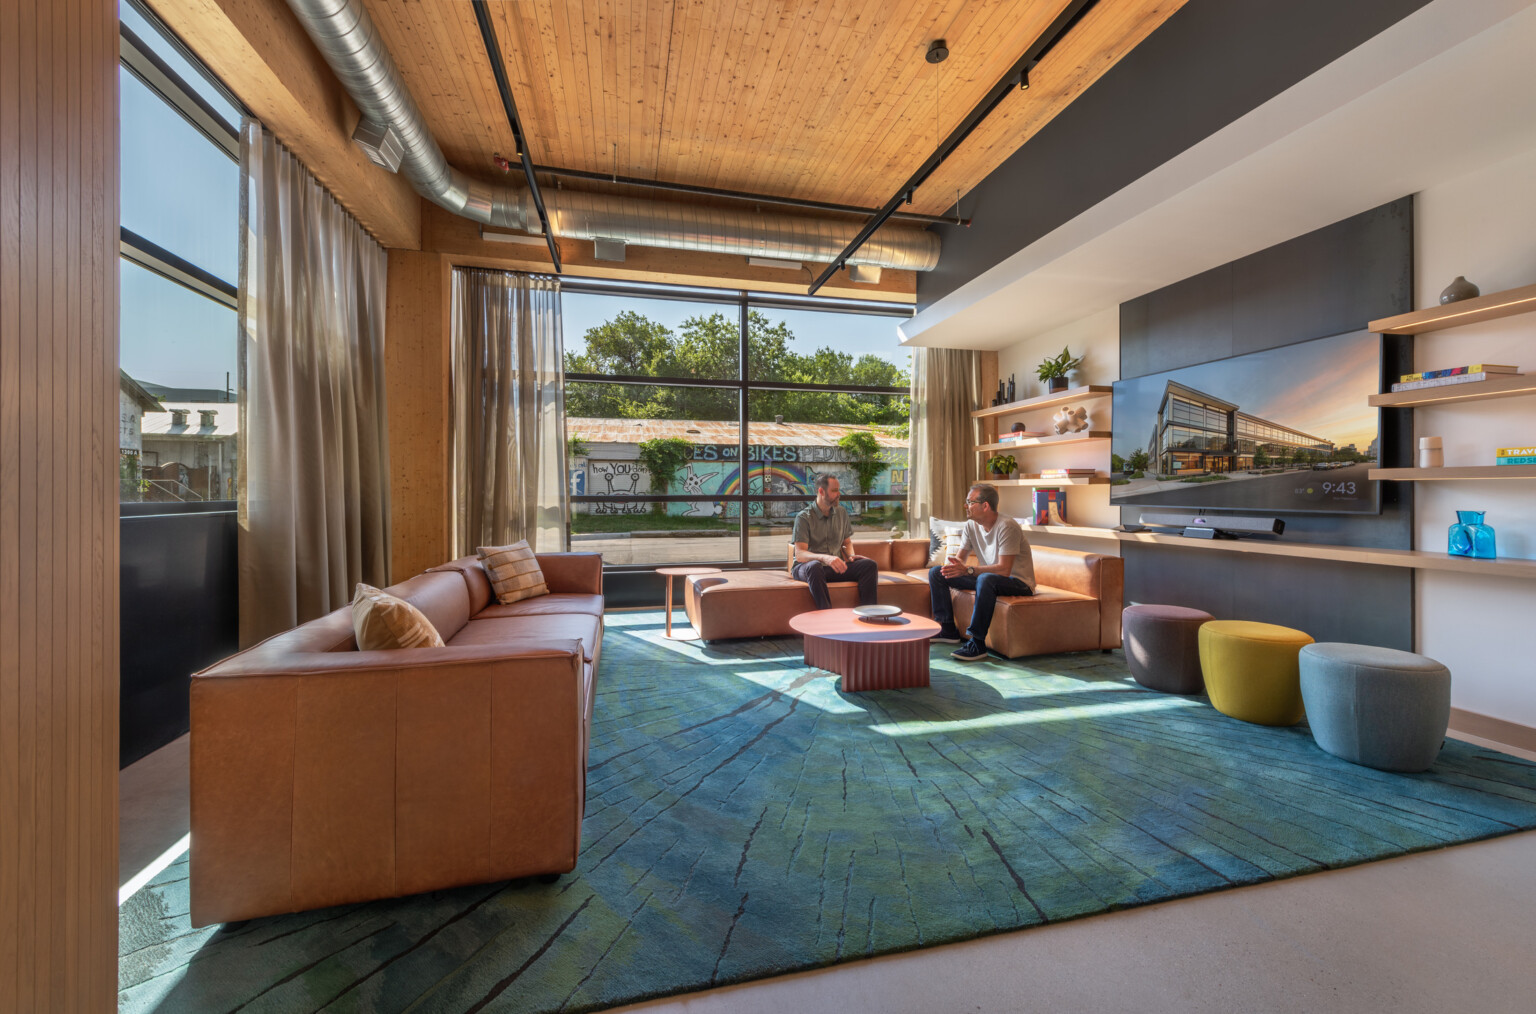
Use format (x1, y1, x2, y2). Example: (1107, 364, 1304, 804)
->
(117, 0, 241, 765)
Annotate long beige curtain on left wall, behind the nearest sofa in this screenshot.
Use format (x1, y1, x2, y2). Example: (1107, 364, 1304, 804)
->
(238, 120, 390, 645)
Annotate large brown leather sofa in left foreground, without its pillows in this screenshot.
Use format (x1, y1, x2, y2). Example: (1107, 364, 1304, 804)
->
(190, 553, 602, 926)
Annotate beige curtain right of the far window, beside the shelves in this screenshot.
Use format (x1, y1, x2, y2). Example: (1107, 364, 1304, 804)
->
(906, 349, 982, 535)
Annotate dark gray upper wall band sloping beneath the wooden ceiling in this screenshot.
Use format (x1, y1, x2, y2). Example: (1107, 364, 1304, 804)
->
(917, 0, 1427, 310)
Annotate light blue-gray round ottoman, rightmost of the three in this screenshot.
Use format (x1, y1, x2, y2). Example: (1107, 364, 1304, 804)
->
(1298, 642, 1450, 771)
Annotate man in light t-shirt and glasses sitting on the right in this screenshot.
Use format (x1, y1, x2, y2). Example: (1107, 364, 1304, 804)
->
(928, 482, 1035, 662)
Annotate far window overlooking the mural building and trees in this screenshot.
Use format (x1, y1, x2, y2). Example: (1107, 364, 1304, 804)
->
(562, 283, 911, 567)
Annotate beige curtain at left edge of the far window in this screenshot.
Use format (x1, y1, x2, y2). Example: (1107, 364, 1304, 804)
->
(452, 269, 570, 555)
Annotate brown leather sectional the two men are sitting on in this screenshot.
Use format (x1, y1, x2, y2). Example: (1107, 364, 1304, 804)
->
(684, 539, 1124, 659)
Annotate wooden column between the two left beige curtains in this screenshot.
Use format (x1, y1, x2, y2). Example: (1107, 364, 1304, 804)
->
(384, 250, 453, 581)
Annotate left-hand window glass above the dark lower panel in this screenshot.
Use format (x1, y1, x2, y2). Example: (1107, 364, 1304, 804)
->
(118, 2, 240, 509)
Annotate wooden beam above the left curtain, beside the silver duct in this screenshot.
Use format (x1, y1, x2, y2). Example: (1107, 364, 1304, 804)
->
(147, 0, 420, 250)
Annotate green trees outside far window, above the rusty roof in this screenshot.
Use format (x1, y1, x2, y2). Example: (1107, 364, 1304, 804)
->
(565, 310, 911, 427)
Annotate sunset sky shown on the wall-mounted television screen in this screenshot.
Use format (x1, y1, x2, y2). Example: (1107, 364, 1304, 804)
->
(1112, 332, 1381, 458)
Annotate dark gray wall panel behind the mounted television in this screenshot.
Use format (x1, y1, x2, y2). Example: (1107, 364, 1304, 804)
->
(1120, 197, 1413, 650)
